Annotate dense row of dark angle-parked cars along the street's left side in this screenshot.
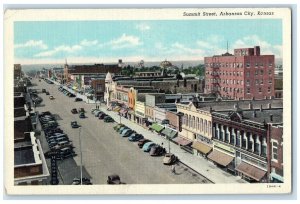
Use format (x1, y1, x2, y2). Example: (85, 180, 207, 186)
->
(39, 111, 75, 160)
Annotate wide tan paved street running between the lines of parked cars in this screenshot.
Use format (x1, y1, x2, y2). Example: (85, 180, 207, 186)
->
(32, 79, 209, 184)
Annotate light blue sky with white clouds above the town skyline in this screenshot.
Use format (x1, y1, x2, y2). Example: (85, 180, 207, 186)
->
(14, 19, 282, 64)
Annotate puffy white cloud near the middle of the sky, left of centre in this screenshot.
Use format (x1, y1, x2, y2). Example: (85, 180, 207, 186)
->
(108, 33, 142, 49)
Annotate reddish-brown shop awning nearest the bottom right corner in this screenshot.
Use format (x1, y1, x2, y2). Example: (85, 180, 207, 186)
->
(236, 162, 267, 181)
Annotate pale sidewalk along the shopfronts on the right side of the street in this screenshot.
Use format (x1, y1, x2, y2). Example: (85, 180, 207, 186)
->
(100, 106, 247, 184)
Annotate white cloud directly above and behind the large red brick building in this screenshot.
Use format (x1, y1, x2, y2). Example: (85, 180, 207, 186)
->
(232, 35, 282, 58)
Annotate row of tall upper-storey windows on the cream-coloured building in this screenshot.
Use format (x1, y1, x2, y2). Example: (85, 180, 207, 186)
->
(182, 114, 212, 135)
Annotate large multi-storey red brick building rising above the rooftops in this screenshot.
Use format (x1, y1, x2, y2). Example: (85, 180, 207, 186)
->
(204, 46, 275, 99)
